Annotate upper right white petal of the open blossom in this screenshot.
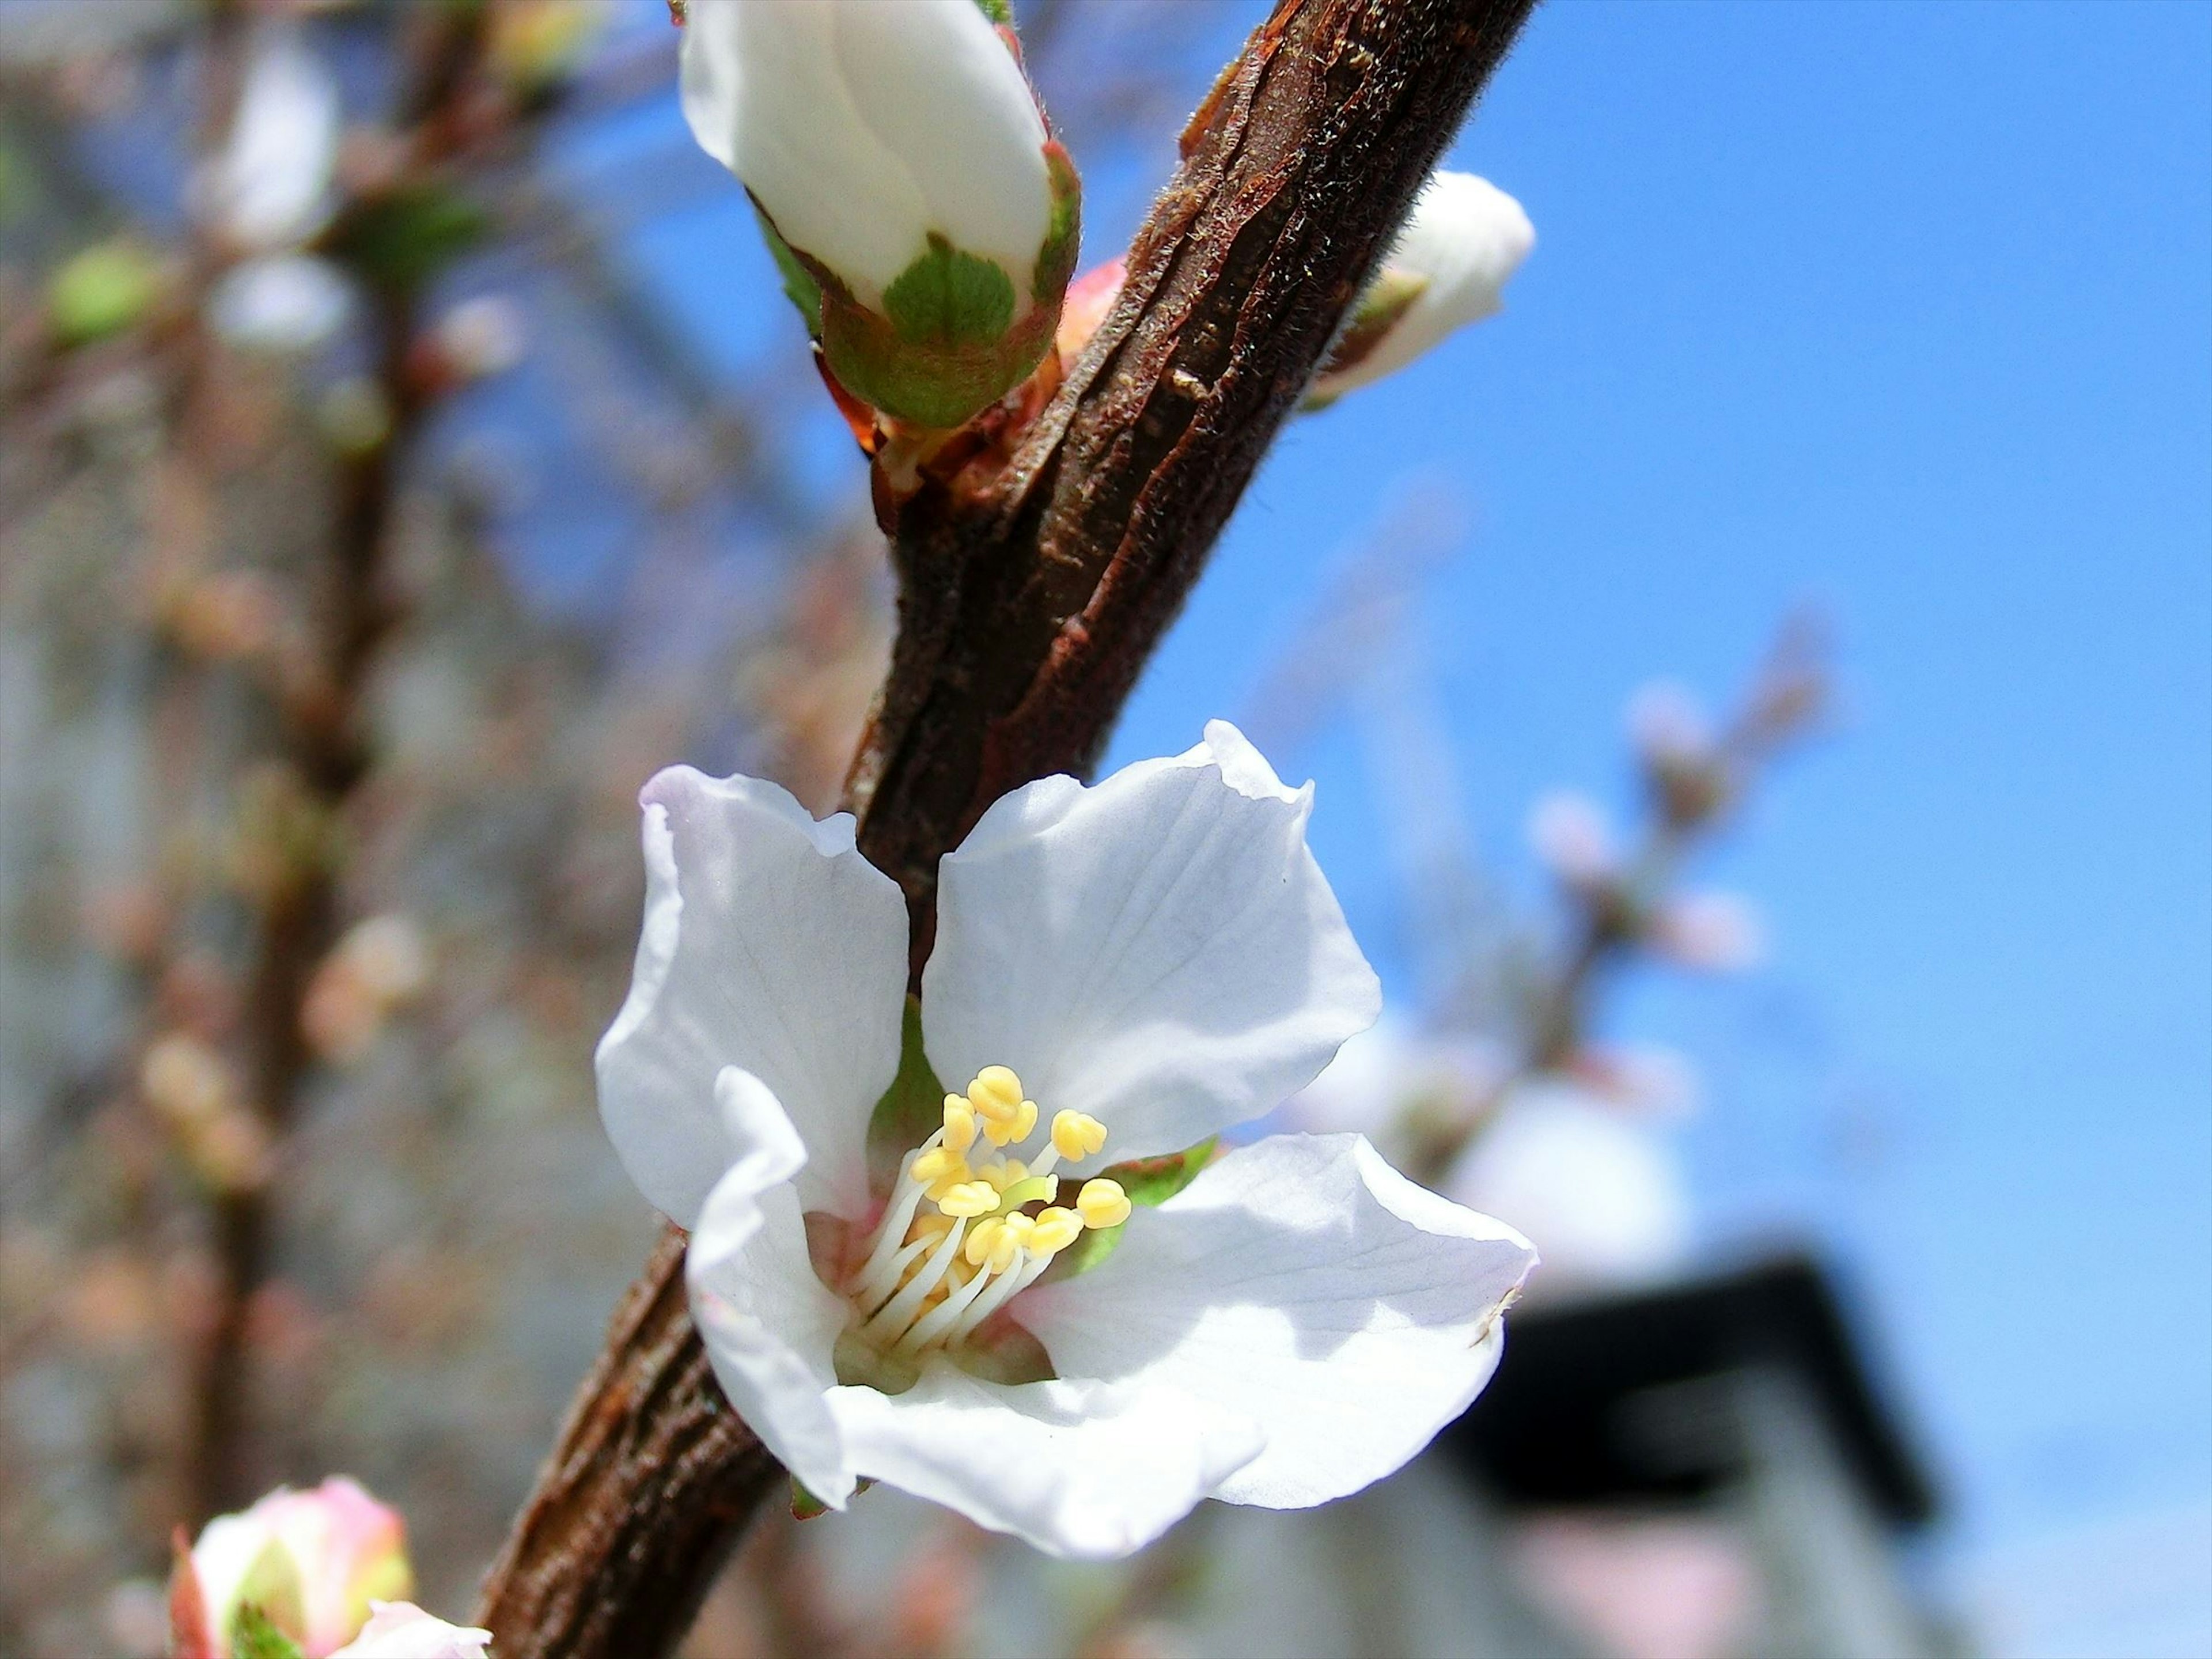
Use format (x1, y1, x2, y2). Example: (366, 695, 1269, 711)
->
(922, 721, 1382, 1170)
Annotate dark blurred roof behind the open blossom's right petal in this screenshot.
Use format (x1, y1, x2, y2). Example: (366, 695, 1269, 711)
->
(1440, 1256, 1936, 1524)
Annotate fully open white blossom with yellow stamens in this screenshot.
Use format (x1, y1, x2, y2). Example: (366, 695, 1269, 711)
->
(600, 724, 1533, 1555)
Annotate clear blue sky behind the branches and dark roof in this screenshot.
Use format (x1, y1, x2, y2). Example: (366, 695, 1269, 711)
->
(601, 0, 2212, 1610)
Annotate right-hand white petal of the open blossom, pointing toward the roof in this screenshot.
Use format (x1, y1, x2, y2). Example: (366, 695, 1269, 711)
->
(1017, 1135, 1535, 1509)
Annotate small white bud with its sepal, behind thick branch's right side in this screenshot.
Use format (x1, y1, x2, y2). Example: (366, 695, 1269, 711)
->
(1309, 171, 1535, 403)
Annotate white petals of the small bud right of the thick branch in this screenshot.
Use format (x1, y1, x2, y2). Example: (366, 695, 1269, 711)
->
(1314, 171, 1535, 398)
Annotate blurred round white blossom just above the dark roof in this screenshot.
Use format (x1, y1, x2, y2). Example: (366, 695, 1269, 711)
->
(1442, 1077, 1690, 1294)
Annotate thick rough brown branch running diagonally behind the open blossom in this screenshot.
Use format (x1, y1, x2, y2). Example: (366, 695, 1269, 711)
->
(478, 0, 1533, 1659)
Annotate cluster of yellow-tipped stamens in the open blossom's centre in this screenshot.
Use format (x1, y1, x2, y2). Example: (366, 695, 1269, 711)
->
(843, 1066, 1130, 1362)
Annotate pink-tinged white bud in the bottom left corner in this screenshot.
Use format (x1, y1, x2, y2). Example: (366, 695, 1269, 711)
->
(173, 1475, 414, 1659)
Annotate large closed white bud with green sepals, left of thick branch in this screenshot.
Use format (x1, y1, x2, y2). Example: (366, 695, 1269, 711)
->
(684, 0, 1080, 427)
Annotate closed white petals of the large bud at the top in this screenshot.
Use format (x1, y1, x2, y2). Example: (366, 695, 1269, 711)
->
(684, 0, 1053, 314)
